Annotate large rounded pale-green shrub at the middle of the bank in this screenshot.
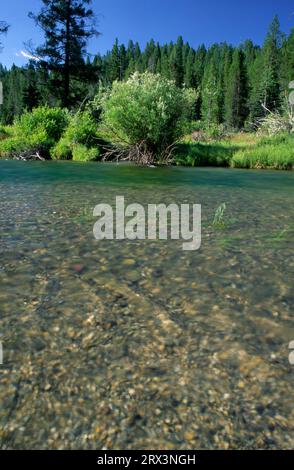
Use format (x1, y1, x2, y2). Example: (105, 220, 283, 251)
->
(102, 72, 195, 163)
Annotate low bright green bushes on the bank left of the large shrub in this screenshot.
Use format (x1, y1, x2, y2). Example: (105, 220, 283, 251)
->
(0, 106, 104, 161)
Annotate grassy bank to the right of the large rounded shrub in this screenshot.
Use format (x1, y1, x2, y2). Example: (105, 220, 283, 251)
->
(175, 133, 294, 170)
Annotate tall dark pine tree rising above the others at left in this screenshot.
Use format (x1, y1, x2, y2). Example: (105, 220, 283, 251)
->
(29, 0, 98, 106)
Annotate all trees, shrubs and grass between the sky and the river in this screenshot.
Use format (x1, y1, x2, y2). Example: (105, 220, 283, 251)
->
(0, 0, 294, 169)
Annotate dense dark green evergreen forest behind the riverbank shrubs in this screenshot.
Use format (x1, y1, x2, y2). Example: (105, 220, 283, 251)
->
(0, 11, 294, 129)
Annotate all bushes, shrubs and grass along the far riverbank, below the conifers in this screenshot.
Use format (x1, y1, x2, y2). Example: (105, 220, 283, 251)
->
(0, 84, 294, 170)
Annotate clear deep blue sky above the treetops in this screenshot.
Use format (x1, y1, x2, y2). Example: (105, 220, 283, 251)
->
(0, 0, 294, 66)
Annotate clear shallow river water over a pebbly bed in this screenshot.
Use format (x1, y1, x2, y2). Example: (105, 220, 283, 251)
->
(0, 161, 294, 449)
